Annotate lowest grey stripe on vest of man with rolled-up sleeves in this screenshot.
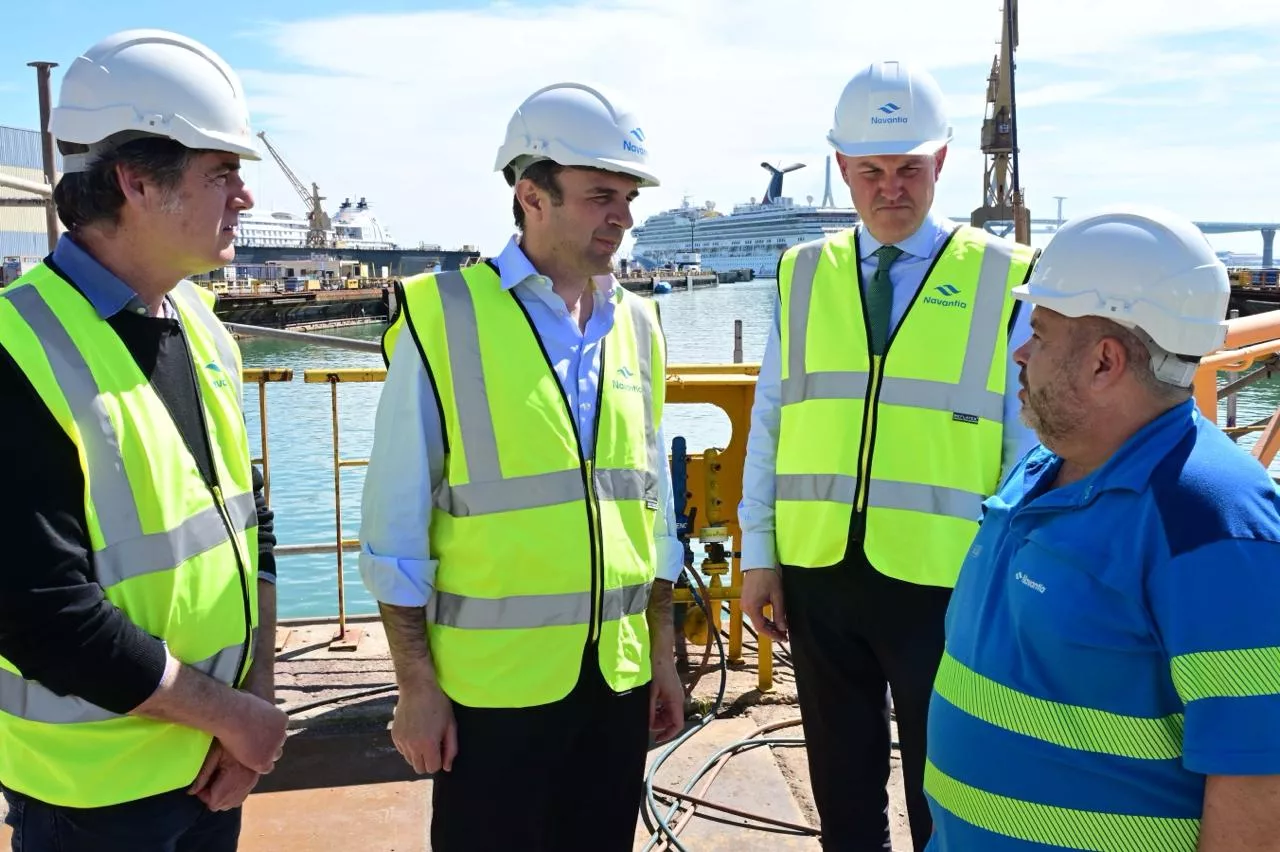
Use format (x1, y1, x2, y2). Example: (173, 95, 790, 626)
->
(426, 583, 649, 631)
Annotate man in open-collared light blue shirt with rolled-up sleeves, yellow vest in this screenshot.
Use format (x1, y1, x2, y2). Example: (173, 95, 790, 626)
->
(360, 83, 684, 852)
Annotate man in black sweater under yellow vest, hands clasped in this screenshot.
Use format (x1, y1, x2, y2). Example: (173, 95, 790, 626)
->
(0, 29, 288, 852)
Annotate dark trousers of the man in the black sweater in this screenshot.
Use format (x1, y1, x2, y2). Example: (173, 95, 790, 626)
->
(4, 788, 241, 852)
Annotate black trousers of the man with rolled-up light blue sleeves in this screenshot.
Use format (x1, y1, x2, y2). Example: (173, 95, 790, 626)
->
(431, 649, 649, 852)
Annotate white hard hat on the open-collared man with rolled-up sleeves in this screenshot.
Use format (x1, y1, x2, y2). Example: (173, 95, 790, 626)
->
(493, 83, 658, 187)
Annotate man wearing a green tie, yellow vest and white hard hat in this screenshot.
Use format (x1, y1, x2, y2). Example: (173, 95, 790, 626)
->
(739, 61, 1034, 852)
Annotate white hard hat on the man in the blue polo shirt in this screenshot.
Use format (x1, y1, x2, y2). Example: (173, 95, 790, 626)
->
(1012, 205, 1231, 378)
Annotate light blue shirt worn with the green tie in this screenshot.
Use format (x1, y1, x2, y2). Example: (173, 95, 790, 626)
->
(737, 214, 1038, 571)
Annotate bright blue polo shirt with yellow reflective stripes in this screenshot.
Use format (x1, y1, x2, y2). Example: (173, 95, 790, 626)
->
(925, 400, 1280, 852)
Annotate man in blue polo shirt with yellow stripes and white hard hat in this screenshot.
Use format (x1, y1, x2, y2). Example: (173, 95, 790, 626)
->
(925, 206, 1280, 852)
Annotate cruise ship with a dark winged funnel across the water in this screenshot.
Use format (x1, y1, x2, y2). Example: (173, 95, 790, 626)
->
(631, 156, 858, 278)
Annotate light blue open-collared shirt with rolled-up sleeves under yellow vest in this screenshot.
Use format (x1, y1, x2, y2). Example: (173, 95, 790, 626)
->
(360, 237, 684, 606)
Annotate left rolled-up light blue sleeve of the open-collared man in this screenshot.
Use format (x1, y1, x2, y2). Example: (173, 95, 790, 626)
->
(360, 335, 444, 606)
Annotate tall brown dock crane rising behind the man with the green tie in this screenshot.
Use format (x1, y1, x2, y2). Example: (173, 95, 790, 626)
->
(969, 0, 1032, 244)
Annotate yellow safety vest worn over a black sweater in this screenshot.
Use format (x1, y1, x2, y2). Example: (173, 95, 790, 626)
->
(0, 265, 257, 807)
